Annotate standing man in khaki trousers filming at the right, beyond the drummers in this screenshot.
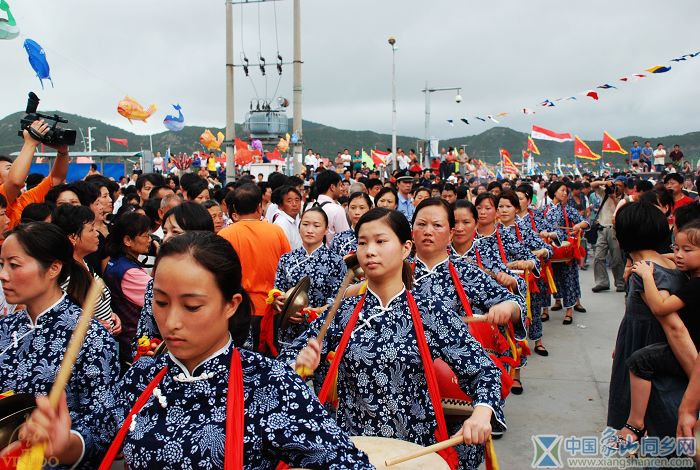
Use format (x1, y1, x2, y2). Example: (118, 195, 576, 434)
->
(591, 176, 627, 292)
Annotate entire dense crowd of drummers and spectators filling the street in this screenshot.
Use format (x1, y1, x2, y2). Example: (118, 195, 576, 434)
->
(0, 121, 700, 469)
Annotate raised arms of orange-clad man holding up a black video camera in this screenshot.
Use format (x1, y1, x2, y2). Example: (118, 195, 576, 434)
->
(0, 120, 68, 230)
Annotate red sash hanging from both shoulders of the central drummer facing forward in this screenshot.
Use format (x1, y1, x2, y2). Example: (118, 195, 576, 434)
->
(318, 291, 459, 470)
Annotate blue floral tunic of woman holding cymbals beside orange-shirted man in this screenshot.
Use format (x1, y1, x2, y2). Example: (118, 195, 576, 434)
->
(275, 244, 347, 344)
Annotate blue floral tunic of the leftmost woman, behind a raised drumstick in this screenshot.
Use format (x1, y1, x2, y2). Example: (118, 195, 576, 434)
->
(0, 295, 119, 468)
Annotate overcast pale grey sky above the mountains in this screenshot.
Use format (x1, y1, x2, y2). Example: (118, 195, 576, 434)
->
(0, 0, 700, 142)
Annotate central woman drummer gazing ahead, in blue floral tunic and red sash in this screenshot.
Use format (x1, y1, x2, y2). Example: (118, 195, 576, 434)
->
(282, 208, 506, 469)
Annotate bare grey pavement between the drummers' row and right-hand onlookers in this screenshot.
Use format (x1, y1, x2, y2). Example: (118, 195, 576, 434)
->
(495, 267, 624, 470)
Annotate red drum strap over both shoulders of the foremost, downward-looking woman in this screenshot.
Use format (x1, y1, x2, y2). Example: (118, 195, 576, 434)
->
(99, 348, 244, 470)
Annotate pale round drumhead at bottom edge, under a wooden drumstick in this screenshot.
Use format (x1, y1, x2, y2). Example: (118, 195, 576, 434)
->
(350, 436, 450, 470)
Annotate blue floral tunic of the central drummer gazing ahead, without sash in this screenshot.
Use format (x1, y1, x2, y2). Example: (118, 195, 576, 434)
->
(278, 289, 504, 468)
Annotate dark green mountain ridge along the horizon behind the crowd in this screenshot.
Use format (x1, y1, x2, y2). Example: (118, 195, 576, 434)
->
(0, 111, 700, 162)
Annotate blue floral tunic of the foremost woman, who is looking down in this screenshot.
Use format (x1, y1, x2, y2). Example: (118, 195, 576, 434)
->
(98, 341, 374, 470)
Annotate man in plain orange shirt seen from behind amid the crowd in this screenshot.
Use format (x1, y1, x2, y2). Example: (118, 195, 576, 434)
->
(219, 183, 291, 356)
